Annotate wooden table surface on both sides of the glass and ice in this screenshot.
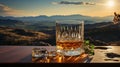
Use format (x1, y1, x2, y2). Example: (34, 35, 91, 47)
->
(0, 46, 120, 63)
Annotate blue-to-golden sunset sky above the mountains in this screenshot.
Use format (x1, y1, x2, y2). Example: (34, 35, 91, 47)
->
(0, 0, 120, 17)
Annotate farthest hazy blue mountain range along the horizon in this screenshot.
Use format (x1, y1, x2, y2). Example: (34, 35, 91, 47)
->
(0, 14, 113, 24)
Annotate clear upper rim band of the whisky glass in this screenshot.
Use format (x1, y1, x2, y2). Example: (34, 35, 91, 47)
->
(56, 20, 84, 24)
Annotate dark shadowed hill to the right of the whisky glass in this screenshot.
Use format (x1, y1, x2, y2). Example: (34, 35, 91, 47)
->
(85, 22, 120, 45)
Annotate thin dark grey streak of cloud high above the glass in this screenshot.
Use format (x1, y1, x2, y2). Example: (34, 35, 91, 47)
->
(52, 1, 95, 5)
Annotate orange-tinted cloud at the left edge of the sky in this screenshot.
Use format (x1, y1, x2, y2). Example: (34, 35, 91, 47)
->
(0, 3, 22, 16)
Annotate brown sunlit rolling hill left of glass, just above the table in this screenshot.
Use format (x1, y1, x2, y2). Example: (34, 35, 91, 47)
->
(0, 27, 50, 46)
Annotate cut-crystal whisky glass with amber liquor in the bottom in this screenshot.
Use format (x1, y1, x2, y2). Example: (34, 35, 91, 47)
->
(56, 20, 84, 56)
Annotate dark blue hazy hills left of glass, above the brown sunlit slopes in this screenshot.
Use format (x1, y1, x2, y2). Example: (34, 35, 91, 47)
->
(0, 19, 55, 33)
